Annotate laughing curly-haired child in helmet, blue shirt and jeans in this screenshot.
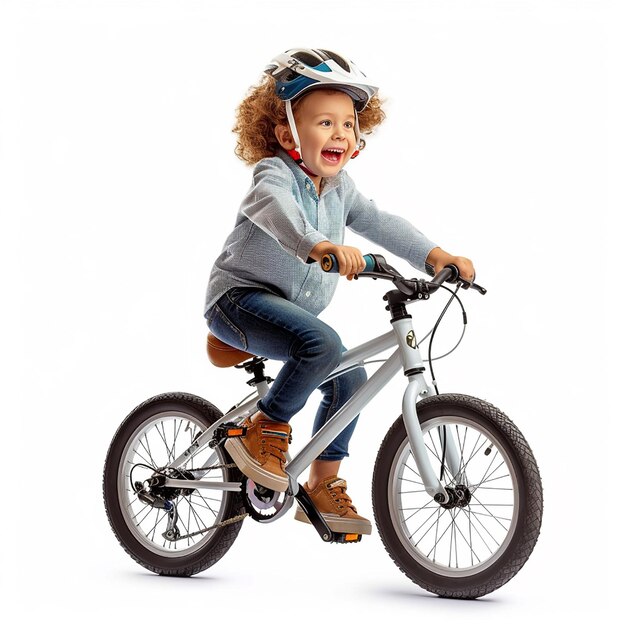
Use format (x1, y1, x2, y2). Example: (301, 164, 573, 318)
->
(205, 49, 474, 534)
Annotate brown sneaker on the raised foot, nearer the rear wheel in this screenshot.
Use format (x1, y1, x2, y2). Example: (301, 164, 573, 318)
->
(224, 418, 291, 491)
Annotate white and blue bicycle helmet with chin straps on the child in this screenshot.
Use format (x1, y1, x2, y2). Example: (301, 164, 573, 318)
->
(265, 48, 378, 174)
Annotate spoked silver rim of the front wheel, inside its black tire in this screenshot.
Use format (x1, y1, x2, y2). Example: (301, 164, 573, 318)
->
(388, 416, 520, 577)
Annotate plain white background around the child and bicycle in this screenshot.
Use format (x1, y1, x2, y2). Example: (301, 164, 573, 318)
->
(0, 0, 626, 624)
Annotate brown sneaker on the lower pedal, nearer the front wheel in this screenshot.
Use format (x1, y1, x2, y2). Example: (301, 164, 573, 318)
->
(295, 476, 372, 535)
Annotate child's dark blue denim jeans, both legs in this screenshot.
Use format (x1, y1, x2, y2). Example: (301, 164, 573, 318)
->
(207, 287, 367, 461)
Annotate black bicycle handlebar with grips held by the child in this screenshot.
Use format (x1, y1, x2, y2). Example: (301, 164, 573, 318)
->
(320, 254, 487, 295)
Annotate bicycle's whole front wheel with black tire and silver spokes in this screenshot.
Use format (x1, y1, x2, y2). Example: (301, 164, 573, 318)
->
(372, 394, 543, 598)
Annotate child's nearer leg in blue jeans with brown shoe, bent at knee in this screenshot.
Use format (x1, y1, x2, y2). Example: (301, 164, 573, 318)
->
(208, 289, 342, 491)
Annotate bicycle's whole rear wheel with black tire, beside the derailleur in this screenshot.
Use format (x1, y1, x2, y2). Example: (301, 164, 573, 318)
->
(103, 393, 243, 576)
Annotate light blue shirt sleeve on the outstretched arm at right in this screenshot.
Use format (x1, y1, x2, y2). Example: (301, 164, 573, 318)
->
(345, 174, 437, 272)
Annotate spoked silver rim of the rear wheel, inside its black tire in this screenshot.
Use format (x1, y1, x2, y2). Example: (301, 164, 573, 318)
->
(117, 411, 227, 557)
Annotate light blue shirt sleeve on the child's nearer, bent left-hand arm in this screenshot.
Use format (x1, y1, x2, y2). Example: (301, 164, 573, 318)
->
(241, 159, 327, 263)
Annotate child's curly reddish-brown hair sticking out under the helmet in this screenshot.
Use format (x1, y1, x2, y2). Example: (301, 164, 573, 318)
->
(233, 76, 385, 165)
